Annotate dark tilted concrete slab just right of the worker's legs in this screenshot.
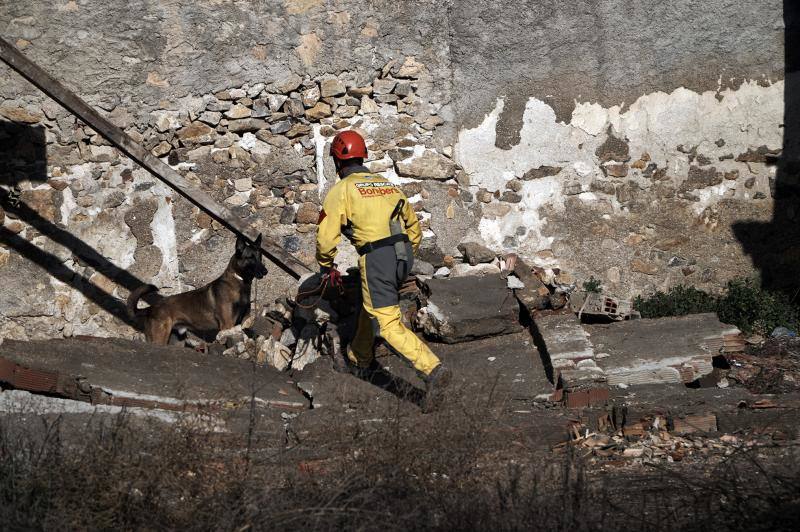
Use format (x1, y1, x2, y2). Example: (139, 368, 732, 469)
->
(419, 274, 522, 343)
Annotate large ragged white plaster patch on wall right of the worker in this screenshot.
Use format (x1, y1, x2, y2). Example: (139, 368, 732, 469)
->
(455, 81, 784, 260)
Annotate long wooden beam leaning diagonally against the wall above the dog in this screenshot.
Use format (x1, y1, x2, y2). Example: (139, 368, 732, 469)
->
(0, 38, 311, 279)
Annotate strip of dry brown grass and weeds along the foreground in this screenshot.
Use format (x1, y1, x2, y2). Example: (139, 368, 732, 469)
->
(0, 396, 800, 531)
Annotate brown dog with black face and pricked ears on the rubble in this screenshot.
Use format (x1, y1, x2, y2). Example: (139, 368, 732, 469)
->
(127, 234, 267, 345)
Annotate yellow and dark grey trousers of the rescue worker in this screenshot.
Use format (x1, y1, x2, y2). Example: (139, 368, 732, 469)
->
(347, 247, 440, 375)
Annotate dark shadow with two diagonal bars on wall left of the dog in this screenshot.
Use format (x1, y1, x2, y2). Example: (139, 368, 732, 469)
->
(0, 122, 147, 328)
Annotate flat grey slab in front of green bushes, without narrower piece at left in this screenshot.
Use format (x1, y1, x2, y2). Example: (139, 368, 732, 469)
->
(585, 314, 741, 386)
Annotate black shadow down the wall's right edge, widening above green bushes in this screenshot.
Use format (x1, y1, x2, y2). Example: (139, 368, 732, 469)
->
(733, 0, 800, 302)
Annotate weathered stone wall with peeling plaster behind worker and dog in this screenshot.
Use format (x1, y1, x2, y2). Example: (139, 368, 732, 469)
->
(0, 0, 784, 337)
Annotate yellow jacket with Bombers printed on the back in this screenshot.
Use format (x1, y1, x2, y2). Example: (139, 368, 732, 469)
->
(317, 168, 422, 268)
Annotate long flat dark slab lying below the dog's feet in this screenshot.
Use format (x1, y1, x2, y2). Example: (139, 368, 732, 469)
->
(0, 337, 308, 410)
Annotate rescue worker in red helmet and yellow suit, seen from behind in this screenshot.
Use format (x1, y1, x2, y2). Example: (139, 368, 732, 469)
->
(316, 131, 452, 412)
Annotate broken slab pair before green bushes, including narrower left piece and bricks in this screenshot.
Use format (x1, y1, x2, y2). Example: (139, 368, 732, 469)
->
(532, 314, 744, 406)
